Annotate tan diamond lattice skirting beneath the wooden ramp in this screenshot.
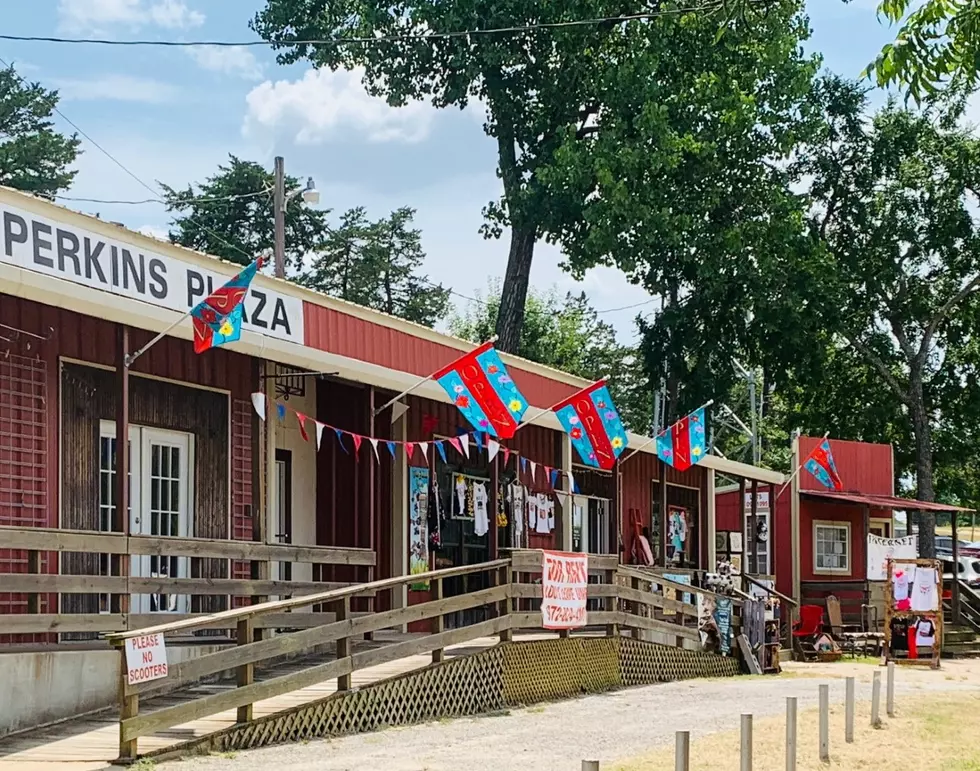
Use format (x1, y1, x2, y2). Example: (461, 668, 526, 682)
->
(150, 637, 738, 755)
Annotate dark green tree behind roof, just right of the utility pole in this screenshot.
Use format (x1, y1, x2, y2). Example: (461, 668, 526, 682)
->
(299, 207, 449, 327)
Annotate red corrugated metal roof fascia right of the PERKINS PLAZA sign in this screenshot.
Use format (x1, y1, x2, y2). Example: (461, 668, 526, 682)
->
(303, 301, 576, 410)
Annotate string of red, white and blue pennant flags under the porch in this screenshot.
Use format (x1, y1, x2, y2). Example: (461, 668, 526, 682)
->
(252, 391, 579, 493)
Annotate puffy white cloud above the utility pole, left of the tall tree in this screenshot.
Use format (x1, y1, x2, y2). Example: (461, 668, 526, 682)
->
(243, 69, 435, 144)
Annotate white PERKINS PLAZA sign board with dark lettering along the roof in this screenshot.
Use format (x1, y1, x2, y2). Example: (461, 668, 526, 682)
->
(0, 202, 304, 345)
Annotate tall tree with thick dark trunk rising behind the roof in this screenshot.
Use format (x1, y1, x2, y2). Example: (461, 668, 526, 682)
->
(252, 0, 782, 351)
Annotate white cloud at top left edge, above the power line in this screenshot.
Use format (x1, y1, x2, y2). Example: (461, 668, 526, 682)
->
(58, 0, 204, 32)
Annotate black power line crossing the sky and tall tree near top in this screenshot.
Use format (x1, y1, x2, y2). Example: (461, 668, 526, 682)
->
(0, 0, 736, 48)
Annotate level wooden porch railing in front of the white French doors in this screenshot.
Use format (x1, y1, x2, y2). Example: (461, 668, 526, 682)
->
(0, 526, 376, 634)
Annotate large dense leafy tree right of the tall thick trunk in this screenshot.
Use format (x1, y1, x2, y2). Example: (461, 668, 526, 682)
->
(538, 0, 818, 422)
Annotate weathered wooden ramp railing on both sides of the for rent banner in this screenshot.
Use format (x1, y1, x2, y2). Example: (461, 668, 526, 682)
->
(106, 551, 737, 759)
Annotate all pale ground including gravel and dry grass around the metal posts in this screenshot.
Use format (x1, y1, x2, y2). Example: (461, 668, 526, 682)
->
(172, 661, 980, 771)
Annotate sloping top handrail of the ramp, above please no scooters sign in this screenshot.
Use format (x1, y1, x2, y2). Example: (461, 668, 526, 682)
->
(105, 559, 510, 645)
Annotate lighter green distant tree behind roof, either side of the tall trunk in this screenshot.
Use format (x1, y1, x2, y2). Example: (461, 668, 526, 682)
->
(449, 281, 652, 433)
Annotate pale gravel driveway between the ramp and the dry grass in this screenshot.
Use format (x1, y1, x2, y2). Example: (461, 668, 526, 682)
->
(176, 661, 980, 771)
